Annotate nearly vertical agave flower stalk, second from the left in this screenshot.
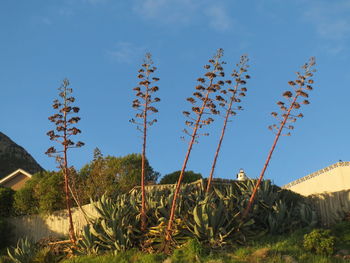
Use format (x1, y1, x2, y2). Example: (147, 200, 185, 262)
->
(130, 53, 160, 231)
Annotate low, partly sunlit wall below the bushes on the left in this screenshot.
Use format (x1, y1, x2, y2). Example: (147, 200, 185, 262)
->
(8, 204, 98, 242)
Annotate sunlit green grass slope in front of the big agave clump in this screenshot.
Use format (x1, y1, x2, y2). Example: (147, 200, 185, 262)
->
(64, 223, 350, 263)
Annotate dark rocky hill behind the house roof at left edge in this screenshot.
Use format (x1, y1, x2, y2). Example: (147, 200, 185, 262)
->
(0, 132, 43, 179)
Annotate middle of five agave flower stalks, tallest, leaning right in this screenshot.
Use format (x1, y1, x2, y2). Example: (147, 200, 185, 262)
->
(165, 49, 224, 242)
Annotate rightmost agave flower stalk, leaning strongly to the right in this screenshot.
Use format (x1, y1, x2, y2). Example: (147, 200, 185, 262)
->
(243, 57, 316, 218)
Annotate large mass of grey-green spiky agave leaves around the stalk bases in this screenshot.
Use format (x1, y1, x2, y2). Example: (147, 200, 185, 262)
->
(74, 180, 317, 254)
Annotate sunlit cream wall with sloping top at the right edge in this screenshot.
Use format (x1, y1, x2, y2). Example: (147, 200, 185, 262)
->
(283, 162, 350, 196)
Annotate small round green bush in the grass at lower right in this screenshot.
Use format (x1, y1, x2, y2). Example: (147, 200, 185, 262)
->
(303, 229, 335, 255)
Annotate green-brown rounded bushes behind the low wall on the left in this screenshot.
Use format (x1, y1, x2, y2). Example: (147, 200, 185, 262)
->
(8, 153, 159, 215)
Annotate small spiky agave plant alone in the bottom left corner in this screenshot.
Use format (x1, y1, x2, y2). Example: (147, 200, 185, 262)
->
(7, 238, 36, 263)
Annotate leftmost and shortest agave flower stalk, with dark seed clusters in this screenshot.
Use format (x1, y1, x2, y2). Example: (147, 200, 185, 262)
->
(46, 79, 84, 243)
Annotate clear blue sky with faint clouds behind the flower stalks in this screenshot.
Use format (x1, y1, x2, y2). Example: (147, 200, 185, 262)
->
(0, 0, 350, 185)
